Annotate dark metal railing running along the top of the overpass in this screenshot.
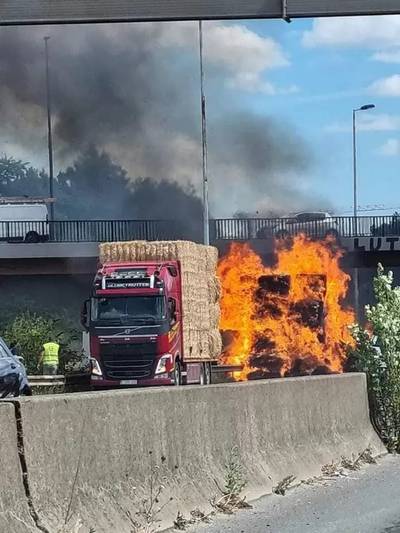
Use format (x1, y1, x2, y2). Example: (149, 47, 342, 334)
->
(0, 215, 400, 243)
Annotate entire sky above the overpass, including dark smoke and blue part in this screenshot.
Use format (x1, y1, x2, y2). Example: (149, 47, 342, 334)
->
(0, 16, 400, 216)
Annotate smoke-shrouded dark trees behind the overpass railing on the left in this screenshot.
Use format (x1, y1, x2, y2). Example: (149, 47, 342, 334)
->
(0, 146, 203, 240)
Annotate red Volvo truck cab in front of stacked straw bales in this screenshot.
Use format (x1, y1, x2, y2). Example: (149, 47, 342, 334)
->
(82, 261, 211, 388)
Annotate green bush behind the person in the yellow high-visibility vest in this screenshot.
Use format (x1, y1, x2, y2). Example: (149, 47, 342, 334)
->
(1, 311, 82, 374)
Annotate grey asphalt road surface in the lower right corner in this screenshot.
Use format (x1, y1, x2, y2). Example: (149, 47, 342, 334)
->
(190, 455, 400, 533)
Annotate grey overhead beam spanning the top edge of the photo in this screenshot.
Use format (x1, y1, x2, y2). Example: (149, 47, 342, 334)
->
(0, 0, 400, 25)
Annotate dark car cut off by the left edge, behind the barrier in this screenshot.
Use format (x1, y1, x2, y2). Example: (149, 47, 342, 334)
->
(0, 337, 32, 398)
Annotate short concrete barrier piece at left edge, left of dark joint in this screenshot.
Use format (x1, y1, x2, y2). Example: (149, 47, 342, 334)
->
(0, 401, 37, 533)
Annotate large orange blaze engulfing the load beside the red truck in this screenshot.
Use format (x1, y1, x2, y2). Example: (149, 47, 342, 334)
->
(218, 236, 354, 379)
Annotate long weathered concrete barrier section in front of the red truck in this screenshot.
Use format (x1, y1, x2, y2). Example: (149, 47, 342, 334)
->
(10, 374, 384, 533)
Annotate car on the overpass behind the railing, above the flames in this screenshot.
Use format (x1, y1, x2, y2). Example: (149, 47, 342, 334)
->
(258, 211, 339, 239)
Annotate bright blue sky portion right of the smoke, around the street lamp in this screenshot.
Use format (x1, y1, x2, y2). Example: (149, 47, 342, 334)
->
(239, 16, 400, 214)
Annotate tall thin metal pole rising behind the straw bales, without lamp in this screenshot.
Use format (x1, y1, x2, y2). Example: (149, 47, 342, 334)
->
(199, 20, 210, 245)
